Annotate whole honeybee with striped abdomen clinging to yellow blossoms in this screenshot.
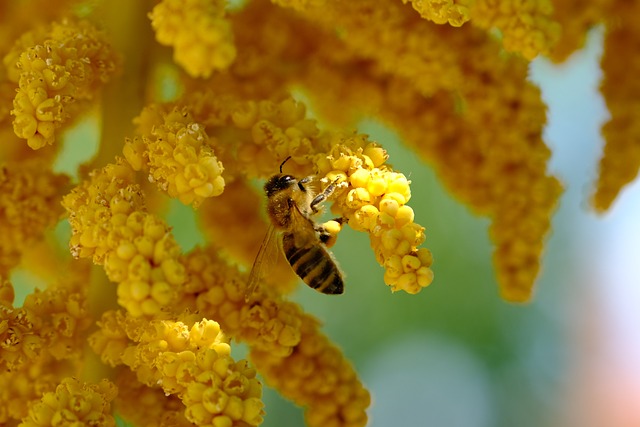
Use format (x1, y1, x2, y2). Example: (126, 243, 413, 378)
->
(245, 156, 344, 301)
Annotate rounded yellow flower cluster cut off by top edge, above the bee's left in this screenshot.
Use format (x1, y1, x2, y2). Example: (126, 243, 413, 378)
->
(149, 0, 236, 77)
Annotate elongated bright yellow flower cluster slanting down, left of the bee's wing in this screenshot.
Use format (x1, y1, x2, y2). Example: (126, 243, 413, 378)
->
(63, 161, 186, 317)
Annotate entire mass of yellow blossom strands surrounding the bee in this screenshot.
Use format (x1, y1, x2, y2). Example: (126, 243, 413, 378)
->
(0, 0, 640, 427)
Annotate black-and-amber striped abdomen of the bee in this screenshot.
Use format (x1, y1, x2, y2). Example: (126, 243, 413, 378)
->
(282, 233, 344, 294)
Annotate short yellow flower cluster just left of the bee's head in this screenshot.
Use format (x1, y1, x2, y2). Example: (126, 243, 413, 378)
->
(123, 105, 225, 208)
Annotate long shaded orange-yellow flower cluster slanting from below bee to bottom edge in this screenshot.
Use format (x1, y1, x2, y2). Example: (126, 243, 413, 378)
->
(182, 250, 369, 427)
